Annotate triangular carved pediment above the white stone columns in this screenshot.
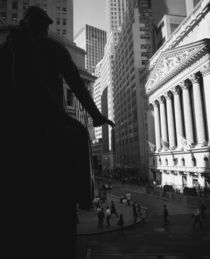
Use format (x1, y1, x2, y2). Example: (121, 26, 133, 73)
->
(146, 39, 210, 94)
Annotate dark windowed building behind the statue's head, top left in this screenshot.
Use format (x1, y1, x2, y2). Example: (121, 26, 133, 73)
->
(0, 0, 73, 41)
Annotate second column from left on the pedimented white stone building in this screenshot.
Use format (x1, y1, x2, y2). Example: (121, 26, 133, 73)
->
(159, 96, 168, 148)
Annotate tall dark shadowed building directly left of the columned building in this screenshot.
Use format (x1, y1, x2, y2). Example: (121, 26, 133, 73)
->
(113, 1, 152, 175)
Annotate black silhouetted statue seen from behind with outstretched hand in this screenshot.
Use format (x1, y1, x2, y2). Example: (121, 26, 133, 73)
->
(0, 6, 114, 258)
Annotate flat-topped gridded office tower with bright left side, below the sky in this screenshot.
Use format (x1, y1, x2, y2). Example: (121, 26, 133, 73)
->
(74, 24, 106, 74)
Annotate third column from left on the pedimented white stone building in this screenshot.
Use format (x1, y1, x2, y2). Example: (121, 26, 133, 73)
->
(166, 92, 176, 149)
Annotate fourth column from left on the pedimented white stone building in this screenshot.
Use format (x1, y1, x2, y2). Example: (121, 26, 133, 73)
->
(173, 87, 184, 149)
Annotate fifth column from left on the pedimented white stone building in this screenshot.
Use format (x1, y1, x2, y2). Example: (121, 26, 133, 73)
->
(180, 81, 194, 144)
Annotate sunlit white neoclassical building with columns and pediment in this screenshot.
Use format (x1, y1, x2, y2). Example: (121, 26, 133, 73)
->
(141, 0, 210, 191)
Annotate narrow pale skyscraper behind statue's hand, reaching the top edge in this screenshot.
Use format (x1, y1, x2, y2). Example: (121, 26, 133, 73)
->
(94, 0, 127, 173)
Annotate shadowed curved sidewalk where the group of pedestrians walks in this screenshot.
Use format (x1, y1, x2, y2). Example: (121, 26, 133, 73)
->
(77, 194, 146, 236)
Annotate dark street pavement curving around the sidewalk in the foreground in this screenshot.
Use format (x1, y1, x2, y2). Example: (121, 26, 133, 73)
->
(78, 183, 210, 259)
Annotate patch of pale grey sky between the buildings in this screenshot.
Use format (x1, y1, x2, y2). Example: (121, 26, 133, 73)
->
(73, 0, 106, 35)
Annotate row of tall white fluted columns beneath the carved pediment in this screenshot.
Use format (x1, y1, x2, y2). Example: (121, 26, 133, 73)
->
(152, 66, 210, 151)
